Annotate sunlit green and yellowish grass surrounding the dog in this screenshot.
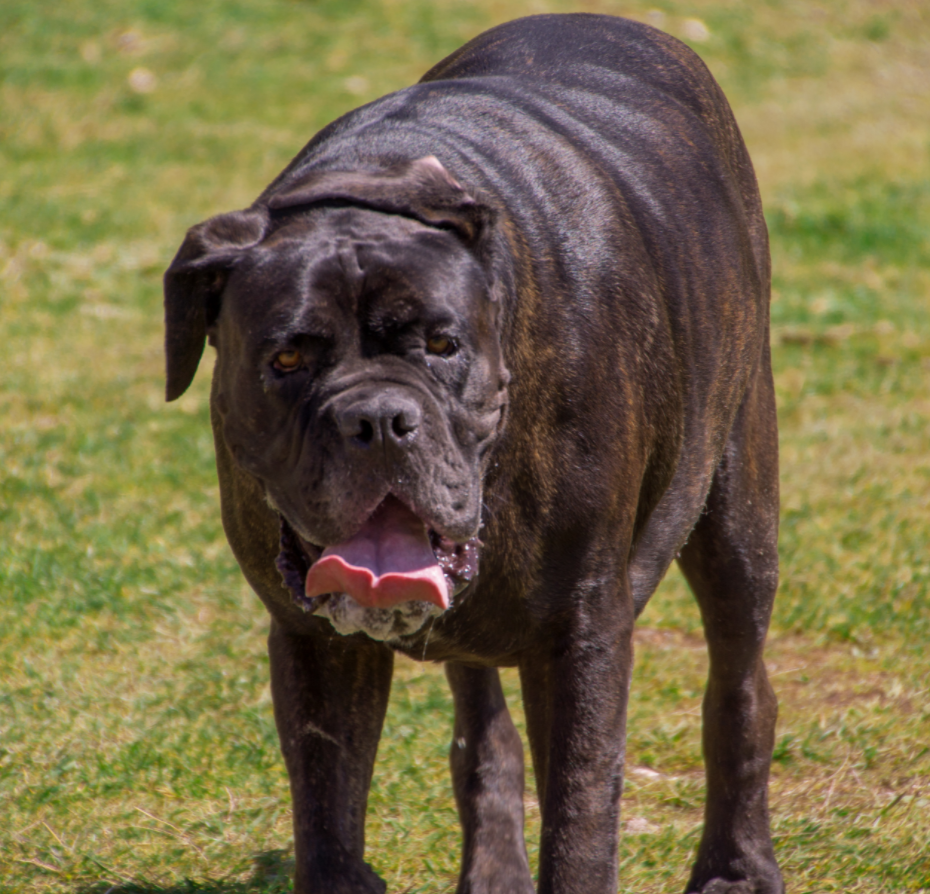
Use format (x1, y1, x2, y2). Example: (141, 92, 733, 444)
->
(0, 0, 930, 894)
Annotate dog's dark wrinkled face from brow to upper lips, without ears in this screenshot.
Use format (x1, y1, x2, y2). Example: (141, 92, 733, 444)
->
(215, 209, 503, 546)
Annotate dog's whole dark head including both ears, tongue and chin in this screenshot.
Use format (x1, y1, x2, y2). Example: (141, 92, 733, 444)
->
(165, 157, 508, 638)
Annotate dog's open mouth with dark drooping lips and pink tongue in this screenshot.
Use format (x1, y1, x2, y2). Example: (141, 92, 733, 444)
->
(276, 495, 480, 612)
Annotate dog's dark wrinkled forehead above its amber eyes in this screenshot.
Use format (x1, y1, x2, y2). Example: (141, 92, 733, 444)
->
(224, 209, 486, 324)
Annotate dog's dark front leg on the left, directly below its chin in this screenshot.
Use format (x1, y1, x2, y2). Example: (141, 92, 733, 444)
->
(268, 621, 394, 894)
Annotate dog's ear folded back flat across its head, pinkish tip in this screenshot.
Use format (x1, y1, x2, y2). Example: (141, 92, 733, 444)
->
(259, 155, 495, 256)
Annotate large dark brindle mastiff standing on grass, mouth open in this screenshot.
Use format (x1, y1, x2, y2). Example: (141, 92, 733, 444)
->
(165, 15, 783, 894)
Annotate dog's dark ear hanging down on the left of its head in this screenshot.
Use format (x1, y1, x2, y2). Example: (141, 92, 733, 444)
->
(164, 208, 268, 400)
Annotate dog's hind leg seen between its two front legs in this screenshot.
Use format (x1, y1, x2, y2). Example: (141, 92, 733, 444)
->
(446, 662, 533, 894)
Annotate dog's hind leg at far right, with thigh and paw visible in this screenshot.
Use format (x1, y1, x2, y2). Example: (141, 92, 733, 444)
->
(678, 346, 784, 894)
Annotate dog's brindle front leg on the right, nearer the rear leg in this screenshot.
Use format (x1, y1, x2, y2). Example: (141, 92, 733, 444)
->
(520, 586, 634, 894)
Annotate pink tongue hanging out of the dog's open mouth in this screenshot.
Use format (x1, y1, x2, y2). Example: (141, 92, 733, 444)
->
(305, 497, 449, 609)
